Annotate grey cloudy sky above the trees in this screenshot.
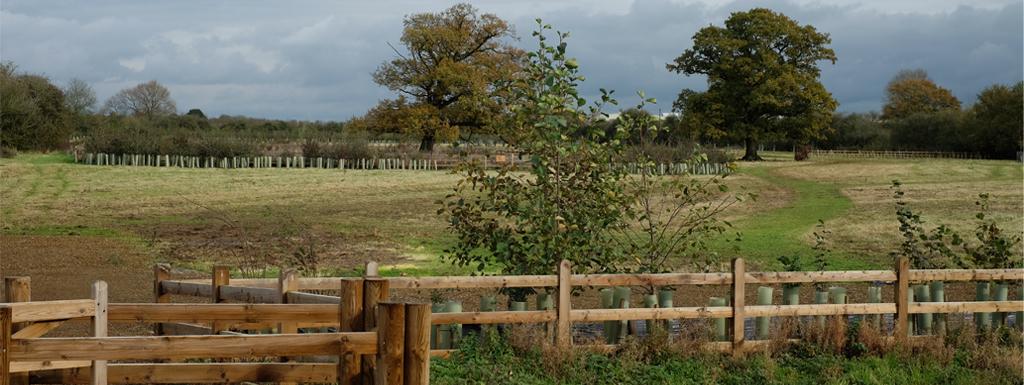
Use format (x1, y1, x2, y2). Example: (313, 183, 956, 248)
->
(0, 0, 1024, 120)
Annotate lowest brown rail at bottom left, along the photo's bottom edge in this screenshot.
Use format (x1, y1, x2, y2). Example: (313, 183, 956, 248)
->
(32, 362, 338, 384)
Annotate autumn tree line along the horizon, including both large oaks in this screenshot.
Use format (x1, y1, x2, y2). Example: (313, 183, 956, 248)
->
(0, 4, 1024, 161)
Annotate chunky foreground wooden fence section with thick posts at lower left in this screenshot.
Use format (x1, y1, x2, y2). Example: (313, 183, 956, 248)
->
(0, 276, 430, 385)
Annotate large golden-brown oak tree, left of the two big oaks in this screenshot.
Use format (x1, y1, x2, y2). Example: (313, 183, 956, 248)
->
(367, 4, 522, 152)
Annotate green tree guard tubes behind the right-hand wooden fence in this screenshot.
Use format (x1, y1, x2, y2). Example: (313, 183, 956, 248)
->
(430, 282, 1024, 349)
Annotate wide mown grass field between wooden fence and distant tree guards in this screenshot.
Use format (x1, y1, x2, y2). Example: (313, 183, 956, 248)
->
(0, 154, 1024, 299)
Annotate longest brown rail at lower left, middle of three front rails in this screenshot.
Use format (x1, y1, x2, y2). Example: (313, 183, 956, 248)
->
(9, 332, 377, 361)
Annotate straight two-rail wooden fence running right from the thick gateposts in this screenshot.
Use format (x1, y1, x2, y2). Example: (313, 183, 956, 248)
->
(151, 259, 1024, 350)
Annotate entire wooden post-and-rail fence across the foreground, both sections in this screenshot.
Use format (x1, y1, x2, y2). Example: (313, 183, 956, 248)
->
(0, 259, 1024, 385)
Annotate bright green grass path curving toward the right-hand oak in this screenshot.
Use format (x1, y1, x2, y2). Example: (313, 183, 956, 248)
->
(716, 164, 873, 269)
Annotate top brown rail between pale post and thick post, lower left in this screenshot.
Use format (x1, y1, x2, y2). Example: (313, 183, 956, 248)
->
(108, 303, 338, 324)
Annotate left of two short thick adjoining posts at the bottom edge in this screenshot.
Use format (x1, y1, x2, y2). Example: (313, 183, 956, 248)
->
(374, 302, 406, 385)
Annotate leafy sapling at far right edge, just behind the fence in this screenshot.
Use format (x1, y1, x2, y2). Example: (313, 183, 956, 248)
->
(964, 194, 1024, 268)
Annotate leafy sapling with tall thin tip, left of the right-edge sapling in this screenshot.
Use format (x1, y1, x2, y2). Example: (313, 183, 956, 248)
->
(890, 180, 967, 268)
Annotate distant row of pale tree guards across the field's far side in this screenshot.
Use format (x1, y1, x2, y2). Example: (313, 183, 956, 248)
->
(75, 153, 730, 175)
